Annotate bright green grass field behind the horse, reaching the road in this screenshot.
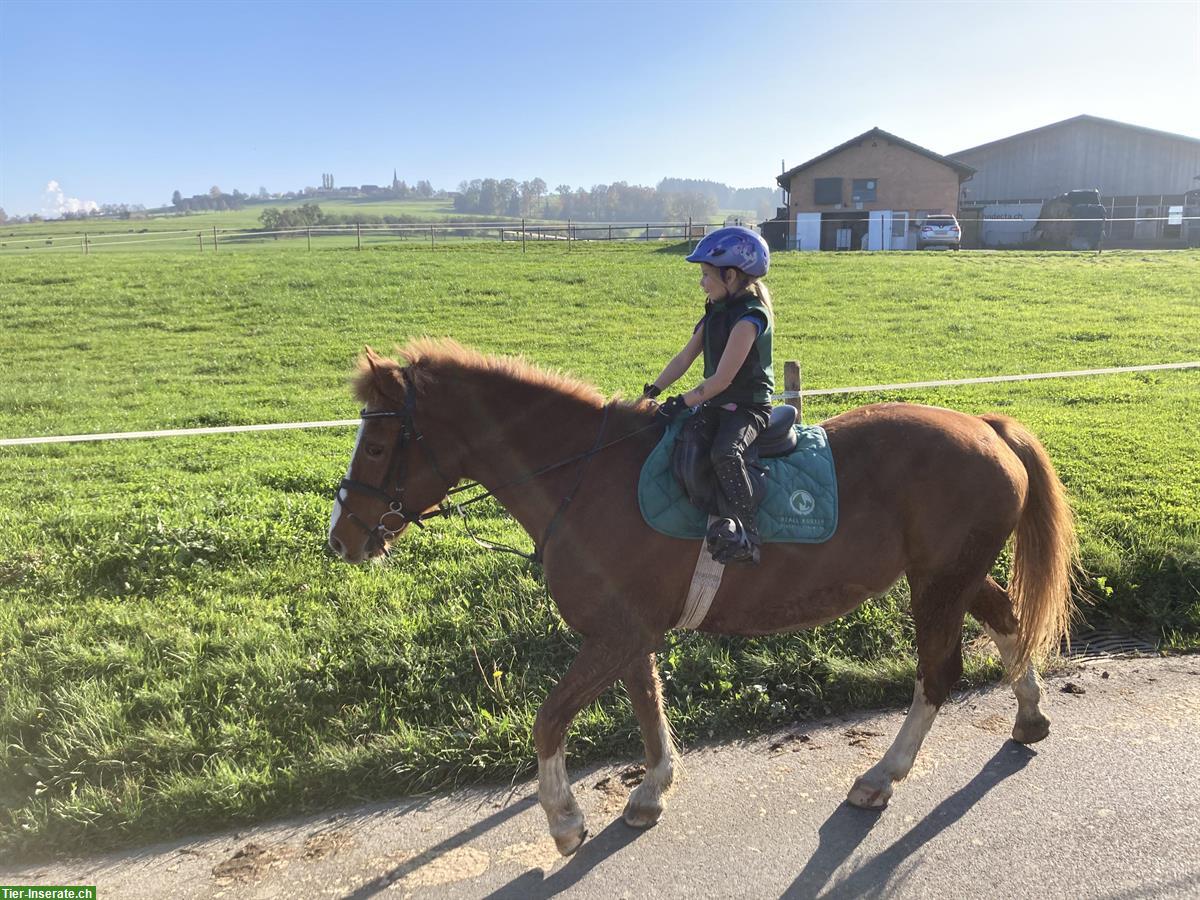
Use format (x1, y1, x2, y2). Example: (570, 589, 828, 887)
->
(0, 245, 1200, 853)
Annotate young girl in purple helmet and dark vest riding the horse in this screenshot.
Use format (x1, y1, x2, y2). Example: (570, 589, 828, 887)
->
(644, 227, 775, 564)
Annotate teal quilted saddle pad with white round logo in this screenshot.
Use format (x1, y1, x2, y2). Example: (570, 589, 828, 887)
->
(637, 419, 838, 544)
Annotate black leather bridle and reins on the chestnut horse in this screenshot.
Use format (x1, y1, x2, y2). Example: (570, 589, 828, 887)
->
(334, 368, 660, 564)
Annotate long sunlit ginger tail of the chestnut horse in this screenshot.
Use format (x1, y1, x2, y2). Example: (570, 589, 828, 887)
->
(982, 415, 1079, 677)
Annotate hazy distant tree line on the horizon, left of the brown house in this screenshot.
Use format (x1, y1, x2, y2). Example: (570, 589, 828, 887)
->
(454, 178, 718, 222)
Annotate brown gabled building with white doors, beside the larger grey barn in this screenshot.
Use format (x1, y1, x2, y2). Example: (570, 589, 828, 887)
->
(776, 128, 974, 250)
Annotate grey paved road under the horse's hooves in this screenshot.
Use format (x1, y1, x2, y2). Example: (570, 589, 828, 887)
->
(0, 656, 1200, 900)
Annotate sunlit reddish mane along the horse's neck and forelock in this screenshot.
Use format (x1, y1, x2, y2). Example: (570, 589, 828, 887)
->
(353, 337, 638, 409)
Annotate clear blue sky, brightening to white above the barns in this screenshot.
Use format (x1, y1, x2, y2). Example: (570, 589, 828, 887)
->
(0, 0, 1200, 215)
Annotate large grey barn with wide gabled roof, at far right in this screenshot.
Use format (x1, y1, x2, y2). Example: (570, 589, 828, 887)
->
(950, 115, 1200, 247)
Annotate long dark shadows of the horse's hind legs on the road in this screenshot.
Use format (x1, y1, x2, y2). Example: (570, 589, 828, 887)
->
(782, 740, 1037, 900)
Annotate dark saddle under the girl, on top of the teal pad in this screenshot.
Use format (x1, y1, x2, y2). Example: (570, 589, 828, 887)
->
(671, 406, 799, 516)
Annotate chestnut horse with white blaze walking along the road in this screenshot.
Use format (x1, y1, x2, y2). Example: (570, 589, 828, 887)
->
(329, 340, 1075, 854)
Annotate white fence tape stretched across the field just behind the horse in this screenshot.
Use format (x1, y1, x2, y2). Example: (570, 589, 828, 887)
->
(0, 360, 1200, 446)
